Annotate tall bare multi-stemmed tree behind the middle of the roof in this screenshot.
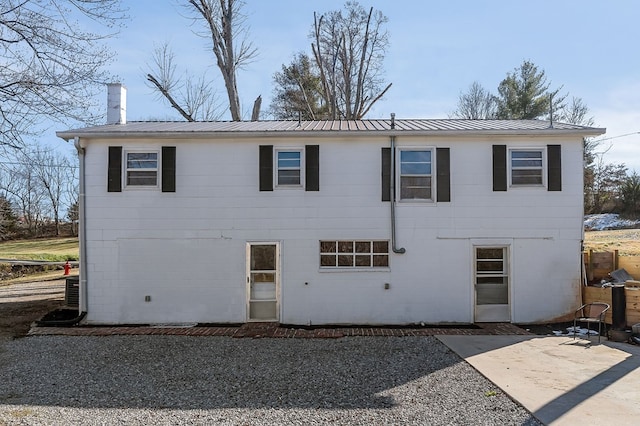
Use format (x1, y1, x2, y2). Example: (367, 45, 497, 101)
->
(311, 2, 391, 119)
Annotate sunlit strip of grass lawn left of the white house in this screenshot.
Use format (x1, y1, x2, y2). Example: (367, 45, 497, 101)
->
(0, 238, 80, 262)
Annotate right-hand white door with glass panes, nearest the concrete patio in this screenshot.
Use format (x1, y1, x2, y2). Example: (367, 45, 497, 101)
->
(474, 246, 511, 322)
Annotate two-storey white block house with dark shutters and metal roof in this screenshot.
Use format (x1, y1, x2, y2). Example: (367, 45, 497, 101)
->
(58, 87, 605, 325)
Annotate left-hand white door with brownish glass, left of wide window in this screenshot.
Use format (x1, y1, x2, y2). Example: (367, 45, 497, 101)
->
(247, 243, 280, 321)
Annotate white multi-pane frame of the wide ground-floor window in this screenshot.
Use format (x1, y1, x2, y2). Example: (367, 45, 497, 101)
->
(318, 239, 391, 271)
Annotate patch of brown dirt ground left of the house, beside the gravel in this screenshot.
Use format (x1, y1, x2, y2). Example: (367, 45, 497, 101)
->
(0, 279, 65, 339)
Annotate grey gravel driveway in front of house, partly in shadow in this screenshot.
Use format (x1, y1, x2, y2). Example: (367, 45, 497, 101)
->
(0, 336, 539, 426)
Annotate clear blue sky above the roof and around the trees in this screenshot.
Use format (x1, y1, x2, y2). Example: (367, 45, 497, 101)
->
(81, 0, 640, 172)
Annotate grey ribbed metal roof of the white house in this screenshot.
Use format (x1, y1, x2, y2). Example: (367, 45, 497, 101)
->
(56, 119, 606, 140)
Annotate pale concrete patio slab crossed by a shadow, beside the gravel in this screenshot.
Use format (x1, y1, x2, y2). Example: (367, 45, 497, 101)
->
(438, 335, 640, 425)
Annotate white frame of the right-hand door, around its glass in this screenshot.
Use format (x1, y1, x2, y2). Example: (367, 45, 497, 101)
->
(471, 241, 513, 322)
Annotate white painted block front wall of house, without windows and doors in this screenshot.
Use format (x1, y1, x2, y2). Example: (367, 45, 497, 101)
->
(83, 137, 582, 324)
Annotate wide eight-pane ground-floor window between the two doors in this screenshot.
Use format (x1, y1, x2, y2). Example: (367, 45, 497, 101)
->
(320, 240, 389, 268)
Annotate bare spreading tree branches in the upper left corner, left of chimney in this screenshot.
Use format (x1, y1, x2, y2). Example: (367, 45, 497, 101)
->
(0, 0, 123, 150)
